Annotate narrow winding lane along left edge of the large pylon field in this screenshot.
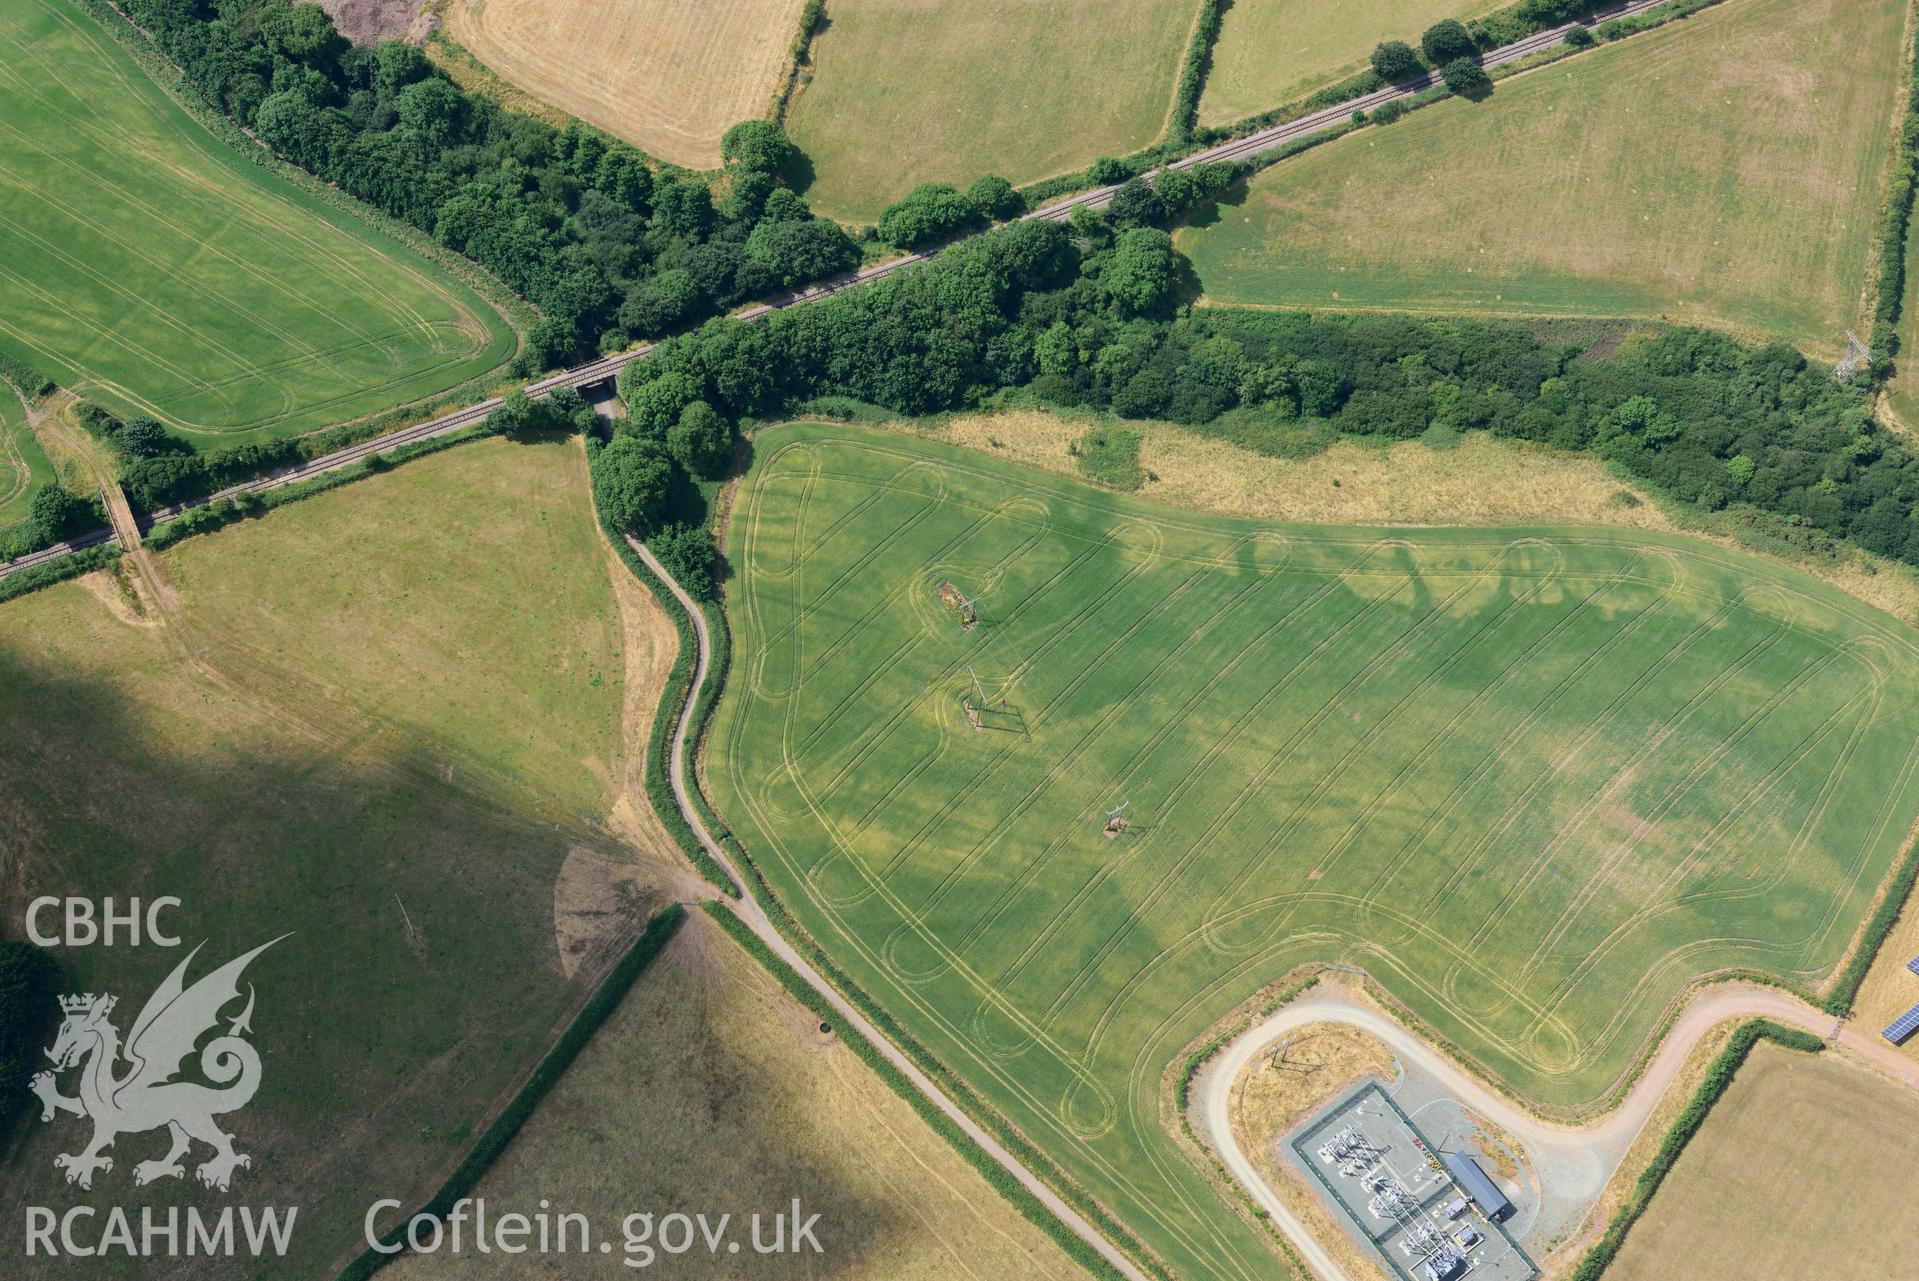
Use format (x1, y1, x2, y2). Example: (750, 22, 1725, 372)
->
(628, 535, 1146, 1281)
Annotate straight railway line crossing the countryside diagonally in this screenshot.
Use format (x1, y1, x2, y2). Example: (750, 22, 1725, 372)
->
(0, 0, 1666, 577)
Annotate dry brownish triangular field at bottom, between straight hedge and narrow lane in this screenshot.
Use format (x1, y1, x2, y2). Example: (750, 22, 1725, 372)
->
(390, 913, 1086, 1281)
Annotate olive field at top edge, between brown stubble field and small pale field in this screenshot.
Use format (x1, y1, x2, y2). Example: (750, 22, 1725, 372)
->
(787, 0, 1197, 222)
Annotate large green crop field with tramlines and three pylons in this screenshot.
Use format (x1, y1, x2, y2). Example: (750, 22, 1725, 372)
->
(708, 426, 1919, 1277)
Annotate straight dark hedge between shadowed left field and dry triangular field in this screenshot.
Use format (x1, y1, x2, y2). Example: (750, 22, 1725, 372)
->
(338, 903, 687, 1281)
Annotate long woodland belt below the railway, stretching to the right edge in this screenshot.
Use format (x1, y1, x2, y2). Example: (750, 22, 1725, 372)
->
(606, 204, 1919, 564)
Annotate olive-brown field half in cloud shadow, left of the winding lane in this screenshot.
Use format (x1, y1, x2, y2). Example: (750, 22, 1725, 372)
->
(0, 441, 656, 1279)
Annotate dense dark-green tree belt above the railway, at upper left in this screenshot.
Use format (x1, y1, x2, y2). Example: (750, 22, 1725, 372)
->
(125, 0, 860, 372)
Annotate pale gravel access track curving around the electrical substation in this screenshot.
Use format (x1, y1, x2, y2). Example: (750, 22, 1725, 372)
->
(1201, 984, 1919, 1281)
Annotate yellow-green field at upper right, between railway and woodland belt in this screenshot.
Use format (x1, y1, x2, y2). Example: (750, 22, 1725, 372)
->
(1180, 0, 1906, 353)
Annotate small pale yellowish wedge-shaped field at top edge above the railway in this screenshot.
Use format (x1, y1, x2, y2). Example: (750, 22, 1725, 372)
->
(1199, 0, 1503, 125)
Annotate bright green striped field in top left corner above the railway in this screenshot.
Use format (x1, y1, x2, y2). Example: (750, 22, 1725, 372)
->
(0, 0, 514, 445)
